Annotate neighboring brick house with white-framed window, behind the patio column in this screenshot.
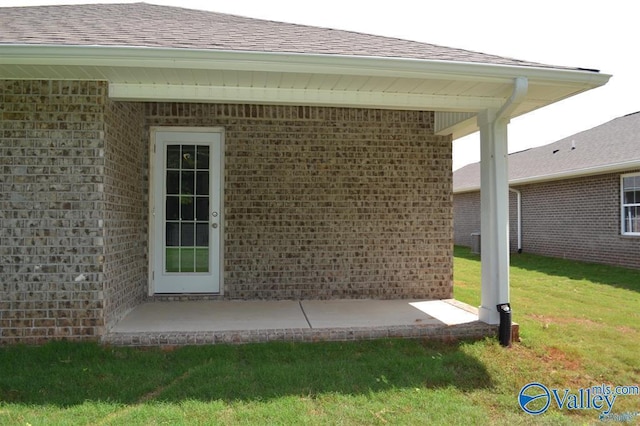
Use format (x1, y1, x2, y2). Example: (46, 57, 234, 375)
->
(453, 113, 640, 268)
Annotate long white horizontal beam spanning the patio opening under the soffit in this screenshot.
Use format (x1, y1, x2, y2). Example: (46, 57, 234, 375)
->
(109, 83, 502, 111)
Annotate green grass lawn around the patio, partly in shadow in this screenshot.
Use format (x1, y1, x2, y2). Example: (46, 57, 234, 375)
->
(0, 248, 640, 425)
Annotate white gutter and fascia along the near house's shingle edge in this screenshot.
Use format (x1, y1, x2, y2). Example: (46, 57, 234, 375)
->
(0, 45, 611, 90)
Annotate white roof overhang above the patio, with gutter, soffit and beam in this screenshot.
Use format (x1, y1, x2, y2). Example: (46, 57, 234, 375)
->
(0, 45, 610, 138)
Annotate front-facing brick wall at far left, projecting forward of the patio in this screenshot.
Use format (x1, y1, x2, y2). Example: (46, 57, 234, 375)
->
(0, 81, 107, 343)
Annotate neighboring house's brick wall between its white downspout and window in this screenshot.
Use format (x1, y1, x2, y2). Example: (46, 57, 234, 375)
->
(518, 173, 640, 268)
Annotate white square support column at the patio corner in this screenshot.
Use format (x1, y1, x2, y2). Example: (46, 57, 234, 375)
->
(478, 110, 509, 324)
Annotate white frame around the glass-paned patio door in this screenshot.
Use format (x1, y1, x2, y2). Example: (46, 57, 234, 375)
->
(148, 126, 225, 296)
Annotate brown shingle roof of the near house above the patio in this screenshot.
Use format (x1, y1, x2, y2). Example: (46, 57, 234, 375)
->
(0, 3, 564, 68)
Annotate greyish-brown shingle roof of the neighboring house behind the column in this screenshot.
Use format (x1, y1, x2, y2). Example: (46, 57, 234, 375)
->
(453, 112, 640, 192)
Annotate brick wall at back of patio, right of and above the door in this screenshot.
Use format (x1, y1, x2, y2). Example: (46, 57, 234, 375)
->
(146, 103, 453, 299)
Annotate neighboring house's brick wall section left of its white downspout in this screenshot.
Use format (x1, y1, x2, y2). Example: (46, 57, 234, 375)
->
(453, 191, 518, 252)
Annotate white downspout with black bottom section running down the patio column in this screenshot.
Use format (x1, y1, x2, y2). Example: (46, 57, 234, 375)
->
(490, 77, 529, 347)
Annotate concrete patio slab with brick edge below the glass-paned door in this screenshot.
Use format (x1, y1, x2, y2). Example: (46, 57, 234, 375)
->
(103, 299, 497, 346)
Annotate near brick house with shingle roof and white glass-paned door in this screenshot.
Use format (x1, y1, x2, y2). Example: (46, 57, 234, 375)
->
(0, 3, 609, 343)
